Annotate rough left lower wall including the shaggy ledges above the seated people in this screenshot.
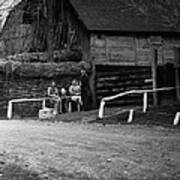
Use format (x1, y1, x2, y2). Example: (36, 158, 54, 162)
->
(0, 51, 92, 117)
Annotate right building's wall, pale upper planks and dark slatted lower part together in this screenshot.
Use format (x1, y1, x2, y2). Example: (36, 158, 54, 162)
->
(91, 35, 180, 105)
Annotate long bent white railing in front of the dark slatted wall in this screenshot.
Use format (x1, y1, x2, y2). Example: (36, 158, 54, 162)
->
(98, 87, 177, 119)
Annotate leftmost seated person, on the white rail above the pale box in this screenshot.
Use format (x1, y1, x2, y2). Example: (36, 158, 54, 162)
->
(48, 81, 62, 114)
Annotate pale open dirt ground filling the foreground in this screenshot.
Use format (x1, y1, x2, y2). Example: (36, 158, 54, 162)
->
(0, 121, 180, 180)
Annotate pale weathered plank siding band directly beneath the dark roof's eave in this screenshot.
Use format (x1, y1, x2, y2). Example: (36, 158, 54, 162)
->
(90, 34, 180, 66)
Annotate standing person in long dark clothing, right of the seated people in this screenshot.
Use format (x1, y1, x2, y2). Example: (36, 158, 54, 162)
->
(81, 69, 91, 111)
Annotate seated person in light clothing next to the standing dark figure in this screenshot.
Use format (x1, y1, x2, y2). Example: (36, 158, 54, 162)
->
(69, 80, 82, 105)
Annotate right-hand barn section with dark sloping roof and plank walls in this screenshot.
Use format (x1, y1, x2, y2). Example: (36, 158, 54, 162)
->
(69, 0, 180, 105)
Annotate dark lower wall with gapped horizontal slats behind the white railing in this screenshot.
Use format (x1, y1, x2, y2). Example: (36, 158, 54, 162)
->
(96, 65, 152, 106)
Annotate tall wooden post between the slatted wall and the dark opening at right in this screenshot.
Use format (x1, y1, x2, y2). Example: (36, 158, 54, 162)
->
(151, 48, 158, 106)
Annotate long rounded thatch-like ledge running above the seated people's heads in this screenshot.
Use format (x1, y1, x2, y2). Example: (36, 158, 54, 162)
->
(0, 60, 92, 79)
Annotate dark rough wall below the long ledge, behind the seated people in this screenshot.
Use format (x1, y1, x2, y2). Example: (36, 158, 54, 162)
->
(0, 75, 79, 118)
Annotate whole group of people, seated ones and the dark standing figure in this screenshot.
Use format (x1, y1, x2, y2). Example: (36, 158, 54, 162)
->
(48, 69, 91, 114)
